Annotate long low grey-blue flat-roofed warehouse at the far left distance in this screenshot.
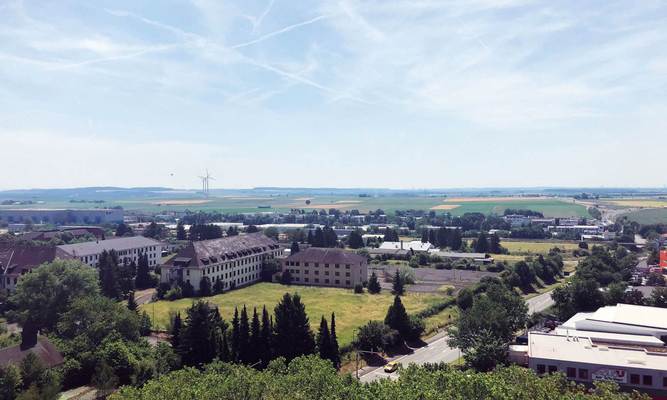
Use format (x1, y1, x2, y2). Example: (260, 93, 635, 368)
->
(0, 208, 123, 225)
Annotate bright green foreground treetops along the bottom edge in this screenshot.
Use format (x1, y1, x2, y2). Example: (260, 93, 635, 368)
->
(111, 356, 650, 400)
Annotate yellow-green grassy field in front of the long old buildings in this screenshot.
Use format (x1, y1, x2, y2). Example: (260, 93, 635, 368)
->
(141, 283, 446, 346)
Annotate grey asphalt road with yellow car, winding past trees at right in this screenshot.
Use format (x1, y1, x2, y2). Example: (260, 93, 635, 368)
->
(359, 292, 554, 382)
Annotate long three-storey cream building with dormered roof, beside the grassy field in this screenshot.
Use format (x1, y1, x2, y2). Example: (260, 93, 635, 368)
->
(160, 232, 283, 290)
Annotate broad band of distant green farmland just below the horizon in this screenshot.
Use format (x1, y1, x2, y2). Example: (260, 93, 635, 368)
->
(0, 195, 588, 217)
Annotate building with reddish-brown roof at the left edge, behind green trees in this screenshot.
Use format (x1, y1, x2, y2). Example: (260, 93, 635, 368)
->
(0, 245, 67, 293)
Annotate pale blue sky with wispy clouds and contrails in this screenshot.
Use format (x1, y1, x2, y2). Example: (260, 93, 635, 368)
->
(0, 0, 667, 189)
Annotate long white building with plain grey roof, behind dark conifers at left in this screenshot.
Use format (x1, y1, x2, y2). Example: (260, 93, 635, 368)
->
(58, 236, 162, 267)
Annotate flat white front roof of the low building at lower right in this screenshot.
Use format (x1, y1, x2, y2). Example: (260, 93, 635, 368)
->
(528, 332, 667, 371)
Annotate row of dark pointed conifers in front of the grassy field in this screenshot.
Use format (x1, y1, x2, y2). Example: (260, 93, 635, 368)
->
(169, 293, 340, 369)
